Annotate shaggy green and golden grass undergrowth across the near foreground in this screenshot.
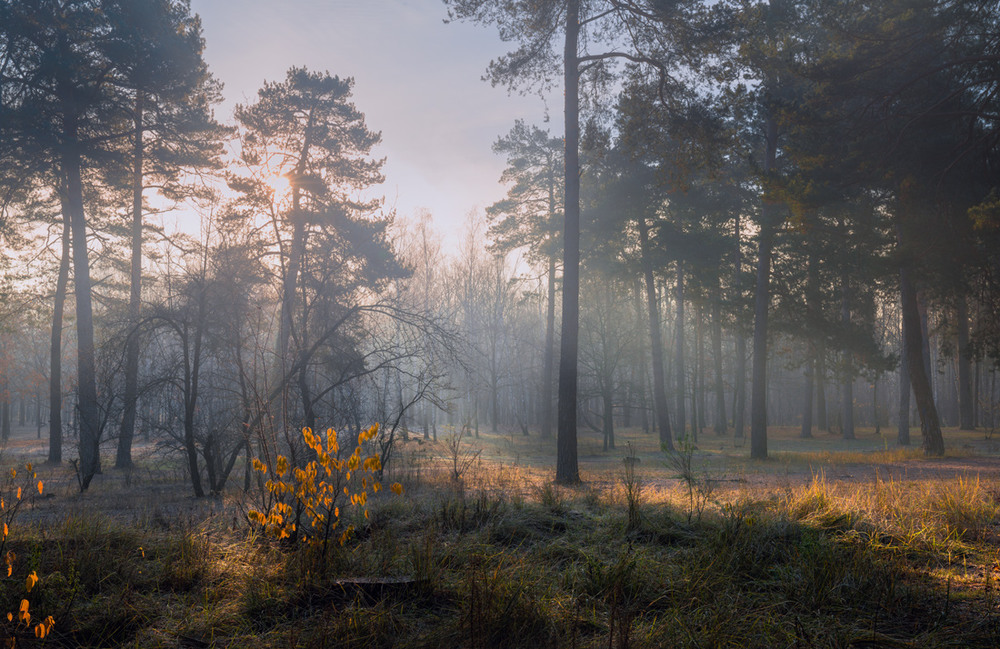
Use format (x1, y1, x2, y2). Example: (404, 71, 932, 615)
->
(0, 464, 1000, 649)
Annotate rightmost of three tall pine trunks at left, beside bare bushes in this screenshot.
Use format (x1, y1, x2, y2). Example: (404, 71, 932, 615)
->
(115, 92, 143, 469)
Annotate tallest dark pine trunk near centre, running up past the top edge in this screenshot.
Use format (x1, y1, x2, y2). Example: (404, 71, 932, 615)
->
(556, 0, 580, 484)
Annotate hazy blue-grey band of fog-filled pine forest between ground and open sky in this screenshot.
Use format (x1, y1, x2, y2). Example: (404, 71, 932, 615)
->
(0, 0, 1000, 496)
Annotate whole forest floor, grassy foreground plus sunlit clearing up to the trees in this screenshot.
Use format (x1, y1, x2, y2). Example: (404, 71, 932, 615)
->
(0, 427, 1000, 649)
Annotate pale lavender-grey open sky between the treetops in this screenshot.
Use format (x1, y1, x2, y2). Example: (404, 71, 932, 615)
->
(191, 0, 562, 246)
